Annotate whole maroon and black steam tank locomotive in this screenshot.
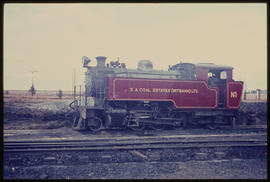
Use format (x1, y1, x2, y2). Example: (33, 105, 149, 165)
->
(70, 56, 243, 131)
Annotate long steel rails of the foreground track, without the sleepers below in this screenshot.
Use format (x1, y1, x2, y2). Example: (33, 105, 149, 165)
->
(4, 134, 267, 152)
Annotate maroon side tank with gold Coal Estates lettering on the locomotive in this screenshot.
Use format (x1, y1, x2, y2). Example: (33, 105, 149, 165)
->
(108, 77, 218, 109)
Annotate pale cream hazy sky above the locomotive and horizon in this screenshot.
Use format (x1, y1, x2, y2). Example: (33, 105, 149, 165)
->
(3, 3, 267, 91)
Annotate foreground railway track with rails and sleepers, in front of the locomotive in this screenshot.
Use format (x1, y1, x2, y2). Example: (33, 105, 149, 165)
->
(4, 134, 267, 166)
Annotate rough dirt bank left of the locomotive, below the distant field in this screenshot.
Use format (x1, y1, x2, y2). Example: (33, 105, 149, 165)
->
(4, 101, 72, 130)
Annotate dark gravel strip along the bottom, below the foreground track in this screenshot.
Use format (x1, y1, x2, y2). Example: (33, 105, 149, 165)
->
(4, 159, 267, 179)
